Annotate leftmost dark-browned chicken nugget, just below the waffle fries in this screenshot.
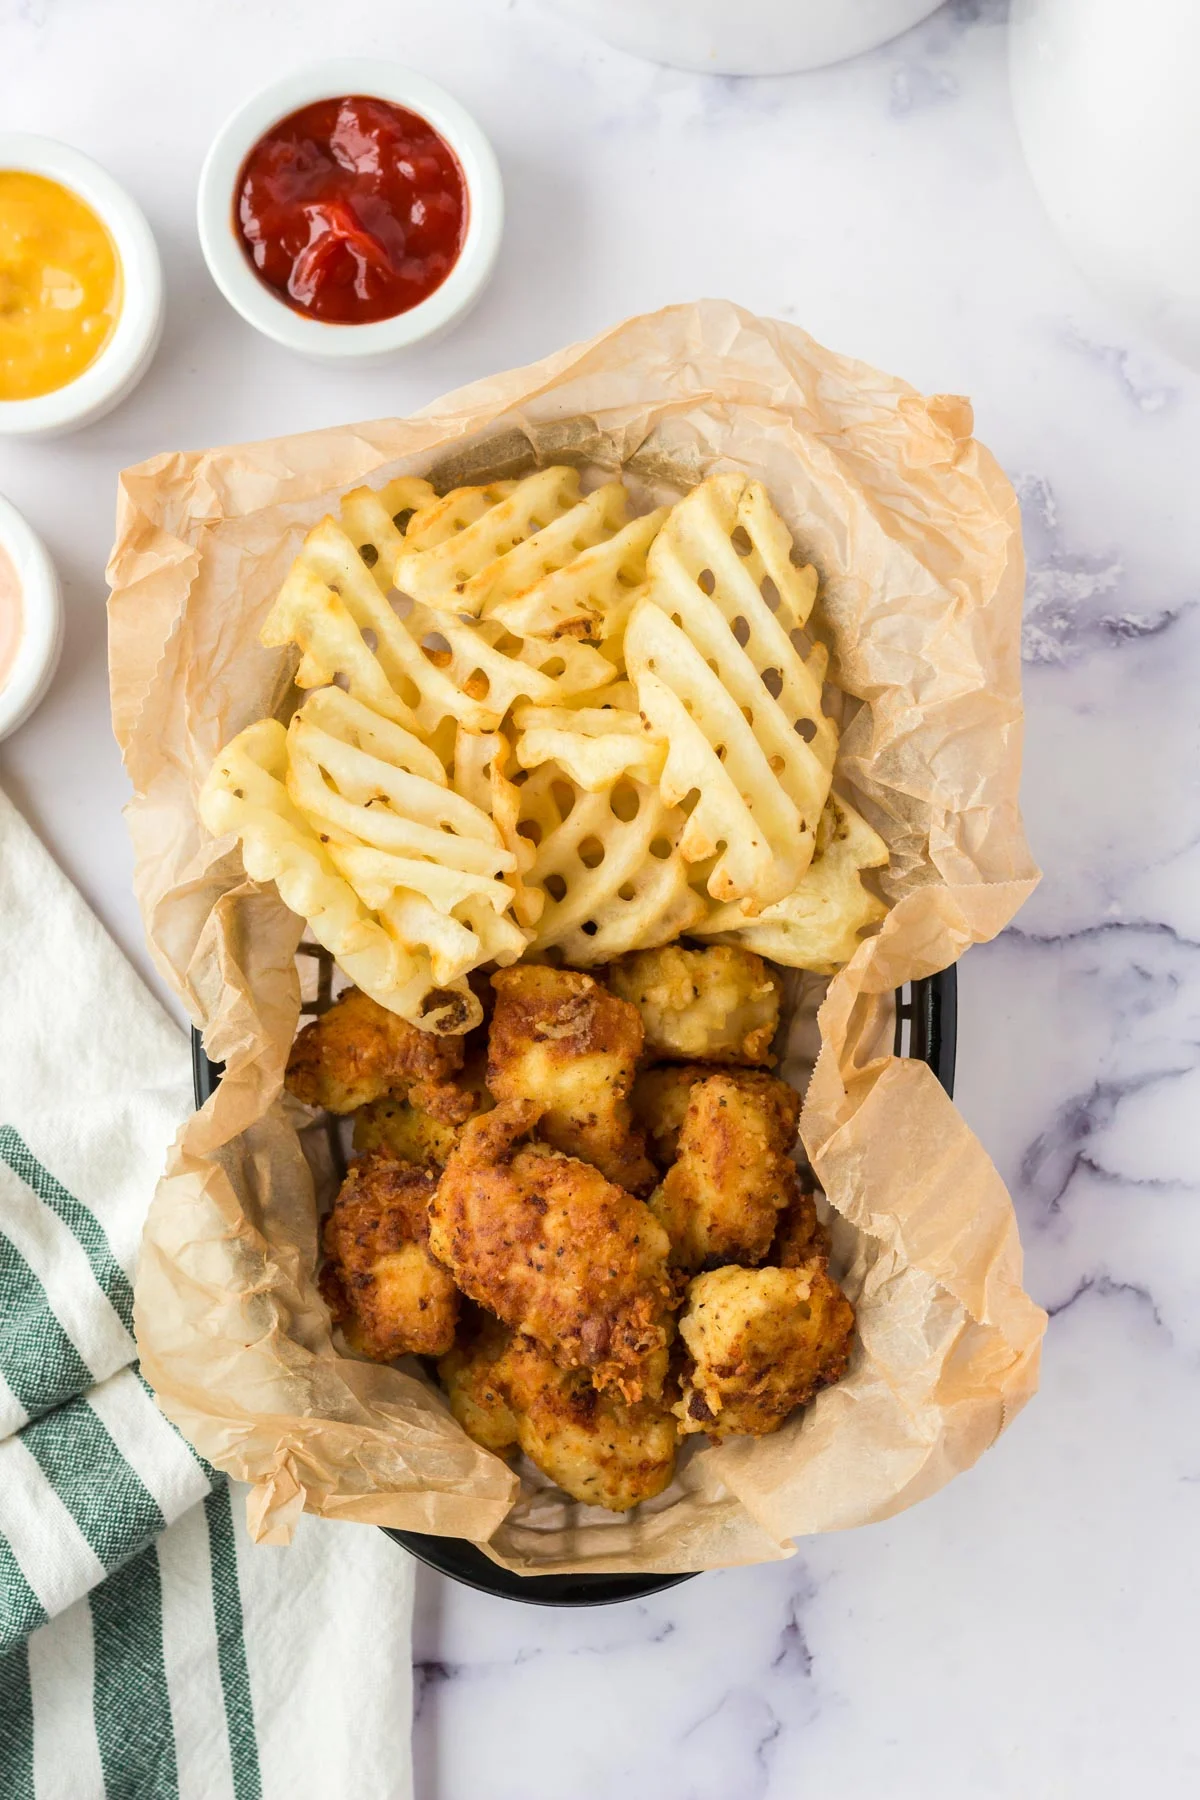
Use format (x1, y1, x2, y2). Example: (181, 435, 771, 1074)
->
(286, 988, 470, 1118)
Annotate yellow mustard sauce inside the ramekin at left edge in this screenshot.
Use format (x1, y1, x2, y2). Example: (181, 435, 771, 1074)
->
(0, 169, 121, 400)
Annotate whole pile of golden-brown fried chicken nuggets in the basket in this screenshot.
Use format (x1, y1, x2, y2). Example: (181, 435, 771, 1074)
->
(288, 943, 855, 1512)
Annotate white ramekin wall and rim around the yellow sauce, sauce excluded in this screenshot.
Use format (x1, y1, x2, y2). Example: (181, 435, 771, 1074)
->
(0, 131, 162, 437)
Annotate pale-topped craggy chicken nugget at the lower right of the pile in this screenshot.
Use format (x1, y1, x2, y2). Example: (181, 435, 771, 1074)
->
(675, 1260, 855, 1438)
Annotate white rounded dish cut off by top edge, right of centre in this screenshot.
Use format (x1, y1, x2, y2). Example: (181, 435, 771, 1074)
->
(539, 0, 941, 76)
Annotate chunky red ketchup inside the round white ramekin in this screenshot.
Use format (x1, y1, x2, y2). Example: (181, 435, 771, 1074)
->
(236, 94, 468, 326)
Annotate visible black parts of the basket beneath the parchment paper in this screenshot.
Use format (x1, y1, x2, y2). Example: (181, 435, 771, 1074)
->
(193, 945, 959, 1606)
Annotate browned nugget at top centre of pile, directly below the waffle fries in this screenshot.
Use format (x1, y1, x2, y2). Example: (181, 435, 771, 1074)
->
(488, 963, 655, 1193)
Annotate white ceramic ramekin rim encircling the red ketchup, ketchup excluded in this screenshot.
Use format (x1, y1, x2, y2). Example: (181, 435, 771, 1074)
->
(196, 56, 504, 364)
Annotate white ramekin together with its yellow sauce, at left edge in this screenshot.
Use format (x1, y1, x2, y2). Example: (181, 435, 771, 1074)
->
(0, 131, 162, 437)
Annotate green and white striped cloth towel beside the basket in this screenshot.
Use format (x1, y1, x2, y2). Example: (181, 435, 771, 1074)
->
(0, 794, 412, 1800)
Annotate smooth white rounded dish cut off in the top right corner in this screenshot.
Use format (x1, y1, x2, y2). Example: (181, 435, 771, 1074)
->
(1009, 0, 1200, 367)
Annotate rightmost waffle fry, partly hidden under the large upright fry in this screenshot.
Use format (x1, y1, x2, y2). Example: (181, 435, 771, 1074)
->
(691, 794, 887, 976)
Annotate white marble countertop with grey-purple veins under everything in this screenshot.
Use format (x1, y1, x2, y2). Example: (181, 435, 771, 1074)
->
(0, 0, 1200, 1800)
